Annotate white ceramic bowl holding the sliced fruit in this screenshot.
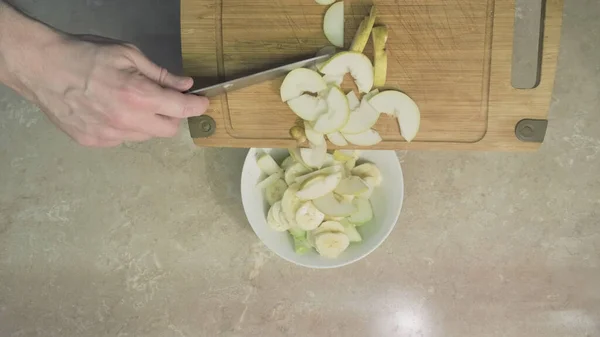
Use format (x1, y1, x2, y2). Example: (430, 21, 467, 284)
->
(242, 148, 404, 268)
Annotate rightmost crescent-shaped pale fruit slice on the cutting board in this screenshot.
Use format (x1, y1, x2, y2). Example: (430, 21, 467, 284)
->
(368, 90, 421, 142)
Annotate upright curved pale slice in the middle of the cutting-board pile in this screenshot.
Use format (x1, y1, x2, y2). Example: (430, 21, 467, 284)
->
(313, 87, 350, 134)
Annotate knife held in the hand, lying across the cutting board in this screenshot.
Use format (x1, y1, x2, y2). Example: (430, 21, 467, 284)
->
(187, 54, 333, 97)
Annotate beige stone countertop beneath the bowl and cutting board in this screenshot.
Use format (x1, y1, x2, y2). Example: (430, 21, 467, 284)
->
(0, 0, 600, 337)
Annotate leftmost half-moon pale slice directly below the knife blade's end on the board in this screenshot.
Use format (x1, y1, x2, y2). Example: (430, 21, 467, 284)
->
(279, 68, 327, 102)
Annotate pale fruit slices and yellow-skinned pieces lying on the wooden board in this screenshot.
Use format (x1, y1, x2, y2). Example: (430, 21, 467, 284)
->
(280, 1, 421, 160)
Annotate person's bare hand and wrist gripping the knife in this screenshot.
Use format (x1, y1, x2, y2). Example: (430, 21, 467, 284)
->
(0, 0, 208, 147)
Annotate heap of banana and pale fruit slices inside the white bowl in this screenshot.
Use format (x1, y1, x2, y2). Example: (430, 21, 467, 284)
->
(257, 149, 382, 258)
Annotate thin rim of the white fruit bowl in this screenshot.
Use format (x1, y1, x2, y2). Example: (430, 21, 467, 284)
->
(240, 147, 404, 269)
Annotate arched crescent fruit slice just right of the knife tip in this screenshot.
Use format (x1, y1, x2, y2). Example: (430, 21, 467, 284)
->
(321, 51, 373, 93)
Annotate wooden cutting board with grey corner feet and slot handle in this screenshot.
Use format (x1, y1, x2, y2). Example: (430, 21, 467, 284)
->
(181, 0, 562, 151)
